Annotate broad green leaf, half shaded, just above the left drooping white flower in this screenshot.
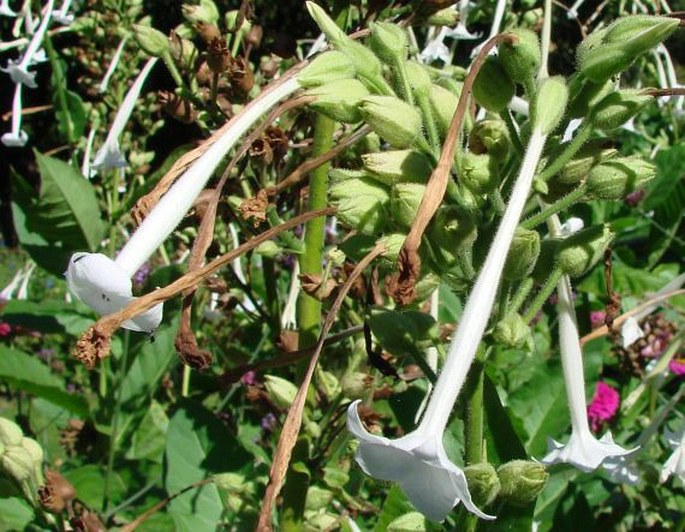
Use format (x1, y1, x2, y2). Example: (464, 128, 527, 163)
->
(12, 152, 105, 276)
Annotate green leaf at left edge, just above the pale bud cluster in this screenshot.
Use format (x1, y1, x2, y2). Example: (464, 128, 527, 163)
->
(0, 346, 88, 417)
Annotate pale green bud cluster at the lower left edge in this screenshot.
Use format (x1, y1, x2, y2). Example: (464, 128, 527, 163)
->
(0, 417, 44, 505)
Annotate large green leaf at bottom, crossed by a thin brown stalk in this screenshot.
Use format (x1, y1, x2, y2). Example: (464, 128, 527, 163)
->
(165, 400, 250, 532)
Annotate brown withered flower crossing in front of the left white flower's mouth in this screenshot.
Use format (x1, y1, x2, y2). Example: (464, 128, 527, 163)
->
(74, 207, 335, 369)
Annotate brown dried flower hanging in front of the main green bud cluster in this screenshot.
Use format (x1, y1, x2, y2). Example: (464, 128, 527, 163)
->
(392, 33, 517, 305)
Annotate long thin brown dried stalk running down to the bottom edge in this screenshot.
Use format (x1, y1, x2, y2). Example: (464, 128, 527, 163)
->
(256, 244, 385, 531)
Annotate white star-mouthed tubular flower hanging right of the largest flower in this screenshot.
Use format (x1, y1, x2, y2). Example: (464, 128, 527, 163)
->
(541, 275, 633, 472)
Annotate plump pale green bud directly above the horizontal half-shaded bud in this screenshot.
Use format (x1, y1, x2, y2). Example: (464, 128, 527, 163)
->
(359, 96, 422, 148)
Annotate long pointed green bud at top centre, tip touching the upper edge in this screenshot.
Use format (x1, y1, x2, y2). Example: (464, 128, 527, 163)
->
(307, 2, 384, 90)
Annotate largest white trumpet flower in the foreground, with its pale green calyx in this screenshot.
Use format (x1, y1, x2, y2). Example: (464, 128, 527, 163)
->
(347, 78, 568, 521)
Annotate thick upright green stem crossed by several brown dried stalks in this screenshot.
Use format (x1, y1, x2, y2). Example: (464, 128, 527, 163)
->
(297, 114, 335, 349)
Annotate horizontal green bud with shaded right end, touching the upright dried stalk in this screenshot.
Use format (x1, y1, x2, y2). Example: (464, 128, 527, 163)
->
(362, 150, 432, 186)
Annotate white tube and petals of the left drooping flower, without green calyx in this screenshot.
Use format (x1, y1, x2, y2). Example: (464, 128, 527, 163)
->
(66, 72, 300, 331)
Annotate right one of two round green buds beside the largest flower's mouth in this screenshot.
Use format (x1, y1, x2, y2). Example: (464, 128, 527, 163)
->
(497, 460, 549, 506)
